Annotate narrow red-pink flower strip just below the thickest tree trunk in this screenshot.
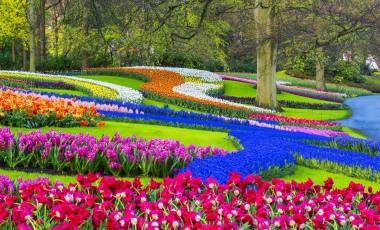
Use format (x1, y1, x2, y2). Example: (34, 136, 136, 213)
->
(248, 113, 337, 127)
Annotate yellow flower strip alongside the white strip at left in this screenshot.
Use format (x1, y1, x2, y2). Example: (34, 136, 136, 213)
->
(0, 73, 118, 99)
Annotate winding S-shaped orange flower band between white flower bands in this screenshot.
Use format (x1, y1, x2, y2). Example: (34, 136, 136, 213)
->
(83, 67, 247, 110)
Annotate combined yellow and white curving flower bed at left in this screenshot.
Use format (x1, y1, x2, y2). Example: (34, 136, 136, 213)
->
(0, 71, 143, 103)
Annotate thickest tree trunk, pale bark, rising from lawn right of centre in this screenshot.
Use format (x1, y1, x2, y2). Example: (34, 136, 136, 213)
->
(255, 0, 278, 109)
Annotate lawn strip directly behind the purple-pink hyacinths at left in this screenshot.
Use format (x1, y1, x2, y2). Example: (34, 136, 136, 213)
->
(5, 121, 236, 150)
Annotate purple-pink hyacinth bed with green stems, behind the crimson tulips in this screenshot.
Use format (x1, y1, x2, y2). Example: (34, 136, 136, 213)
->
(0, 128, 226, 177)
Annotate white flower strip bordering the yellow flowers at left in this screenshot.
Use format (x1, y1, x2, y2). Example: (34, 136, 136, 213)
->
(0, 71, 144, 103)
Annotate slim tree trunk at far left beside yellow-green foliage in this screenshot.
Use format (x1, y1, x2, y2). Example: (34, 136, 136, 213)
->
(29, 0, 36, 72)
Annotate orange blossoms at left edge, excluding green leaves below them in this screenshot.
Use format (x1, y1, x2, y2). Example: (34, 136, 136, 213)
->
(0, 91, 99, 120)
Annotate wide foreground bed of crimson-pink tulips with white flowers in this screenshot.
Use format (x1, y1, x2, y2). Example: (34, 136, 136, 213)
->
(0, 173, 380, 230)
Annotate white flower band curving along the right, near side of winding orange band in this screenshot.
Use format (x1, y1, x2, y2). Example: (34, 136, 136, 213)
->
(173, 82, 274, 113)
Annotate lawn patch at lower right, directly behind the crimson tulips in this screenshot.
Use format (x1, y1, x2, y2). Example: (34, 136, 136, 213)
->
(283, 166, 380, 191)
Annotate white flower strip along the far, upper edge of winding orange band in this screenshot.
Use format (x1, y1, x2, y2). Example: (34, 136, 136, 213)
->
(128, 66, 222, 83)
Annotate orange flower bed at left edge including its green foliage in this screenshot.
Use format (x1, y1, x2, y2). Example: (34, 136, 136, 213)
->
(0, 90, 99, 128)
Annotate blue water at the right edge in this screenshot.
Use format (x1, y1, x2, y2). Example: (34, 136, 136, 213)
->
(339, 95, 380, 141)
